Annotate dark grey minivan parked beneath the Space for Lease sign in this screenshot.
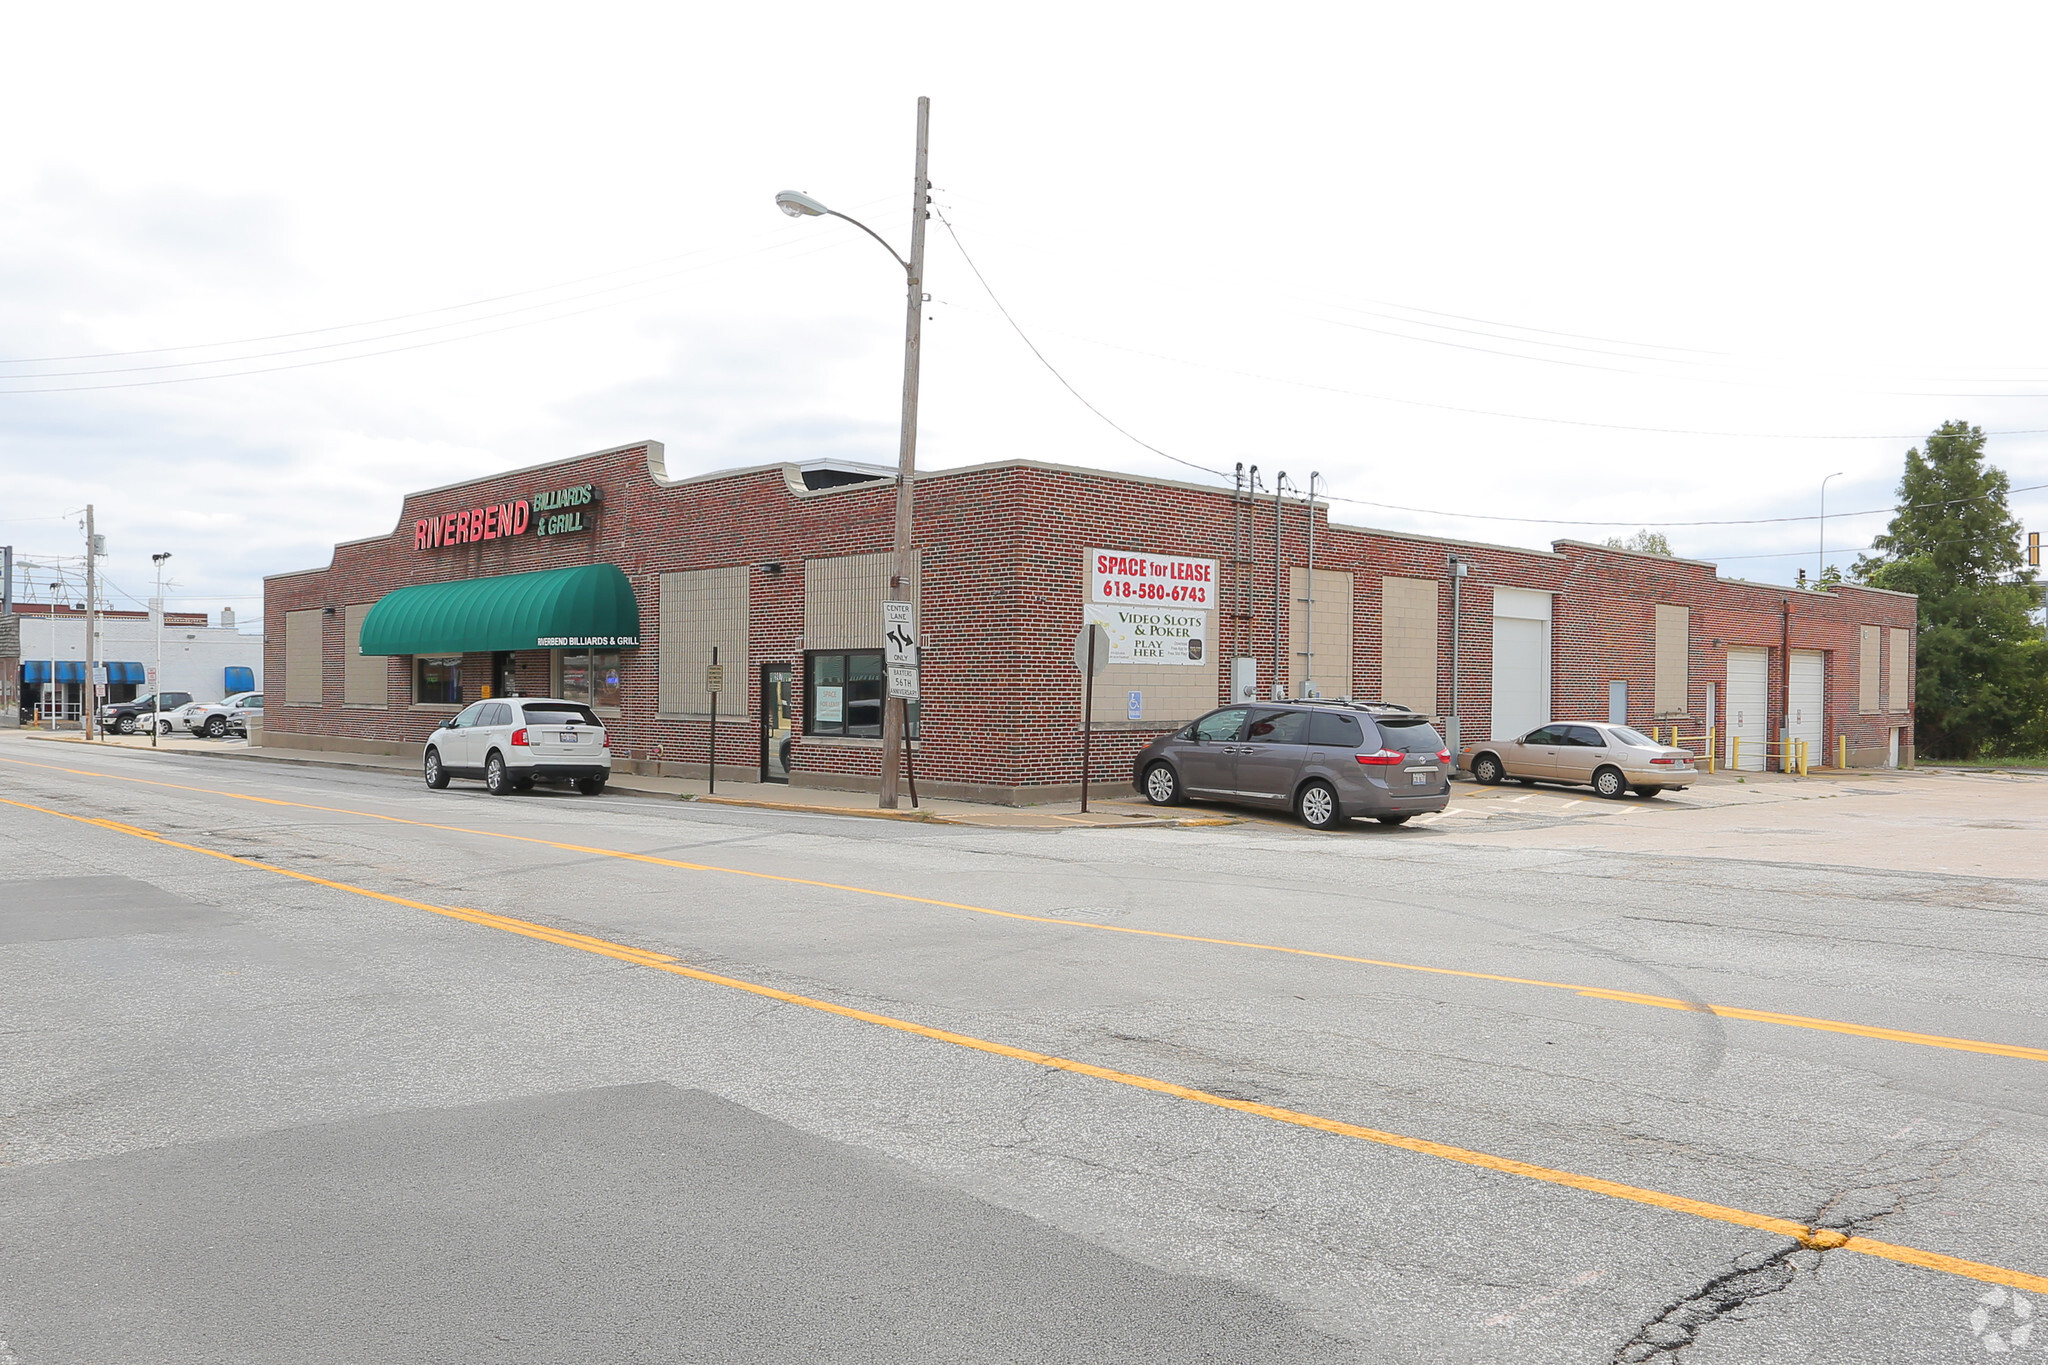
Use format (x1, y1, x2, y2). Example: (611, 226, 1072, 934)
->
(1130, 702, 1452, 829)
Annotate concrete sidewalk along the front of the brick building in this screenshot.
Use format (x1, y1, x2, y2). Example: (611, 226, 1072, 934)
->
(18, 731, 1239, 829)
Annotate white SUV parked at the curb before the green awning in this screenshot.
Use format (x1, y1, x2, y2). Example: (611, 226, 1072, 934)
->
(426, 696, 612, 796)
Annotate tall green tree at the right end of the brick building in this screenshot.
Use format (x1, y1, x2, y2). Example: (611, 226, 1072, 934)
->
(1853, 422, 2048, 759)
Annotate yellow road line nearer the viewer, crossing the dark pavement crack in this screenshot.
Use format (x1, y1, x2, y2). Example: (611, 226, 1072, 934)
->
(0, 796, 2048, 1293)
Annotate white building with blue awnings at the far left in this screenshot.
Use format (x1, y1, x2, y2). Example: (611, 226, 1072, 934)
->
(0, 602, 262, 720)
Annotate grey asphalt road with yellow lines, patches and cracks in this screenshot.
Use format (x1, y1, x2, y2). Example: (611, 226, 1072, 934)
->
(0, 737, 2048, 1365)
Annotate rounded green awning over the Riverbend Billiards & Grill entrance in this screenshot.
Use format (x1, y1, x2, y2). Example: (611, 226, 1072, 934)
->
(362, 565, 639, 655)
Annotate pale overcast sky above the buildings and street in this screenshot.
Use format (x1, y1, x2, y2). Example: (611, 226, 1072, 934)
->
(0, 4, 2048, 614)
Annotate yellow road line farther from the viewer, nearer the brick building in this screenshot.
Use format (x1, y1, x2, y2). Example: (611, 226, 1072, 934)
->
(0, 759, 2048, 1062)
